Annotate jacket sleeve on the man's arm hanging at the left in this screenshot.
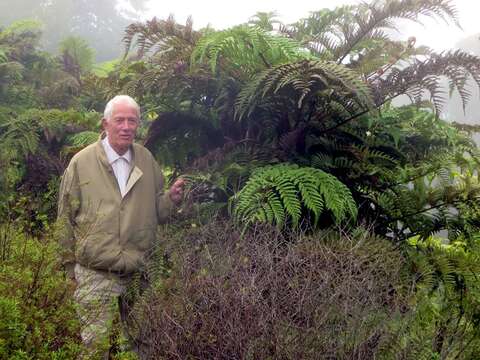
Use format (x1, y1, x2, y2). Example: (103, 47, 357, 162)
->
(57, 163, 80, 278)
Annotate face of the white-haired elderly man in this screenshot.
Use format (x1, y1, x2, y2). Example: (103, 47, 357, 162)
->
(102, 102, 139, 155)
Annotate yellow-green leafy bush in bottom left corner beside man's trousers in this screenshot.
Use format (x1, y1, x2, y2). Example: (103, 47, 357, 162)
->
(0, 225, 80, 359)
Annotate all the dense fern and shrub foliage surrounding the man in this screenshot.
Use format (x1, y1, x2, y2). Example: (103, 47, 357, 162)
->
(0, 0, 480, 359)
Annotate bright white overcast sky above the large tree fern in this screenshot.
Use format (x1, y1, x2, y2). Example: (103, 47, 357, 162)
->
(143, 0, 480, 50)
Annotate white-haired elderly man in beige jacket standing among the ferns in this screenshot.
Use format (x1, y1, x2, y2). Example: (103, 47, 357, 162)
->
(58, 95, 183, 358)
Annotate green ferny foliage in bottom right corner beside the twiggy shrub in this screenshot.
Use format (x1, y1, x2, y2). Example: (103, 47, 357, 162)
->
(384, 238, 480, 359)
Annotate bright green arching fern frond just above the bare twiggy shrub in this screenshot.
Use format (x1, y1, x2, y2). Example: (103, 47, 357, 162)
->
(233, 164, 357, 227)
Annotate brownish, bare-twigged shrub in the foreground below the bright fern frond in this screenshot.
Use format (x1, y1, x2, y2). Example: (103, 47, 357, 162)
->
(131, 222, 406, 359)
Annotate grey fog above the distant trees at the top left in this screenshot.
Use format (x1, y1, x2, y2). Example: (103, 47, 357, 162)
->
(0, 0, 147, 61)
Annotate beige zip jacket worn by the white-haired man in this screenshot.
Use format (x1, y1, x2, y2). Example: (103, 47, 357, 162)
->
(58, 141, 173, 274)
